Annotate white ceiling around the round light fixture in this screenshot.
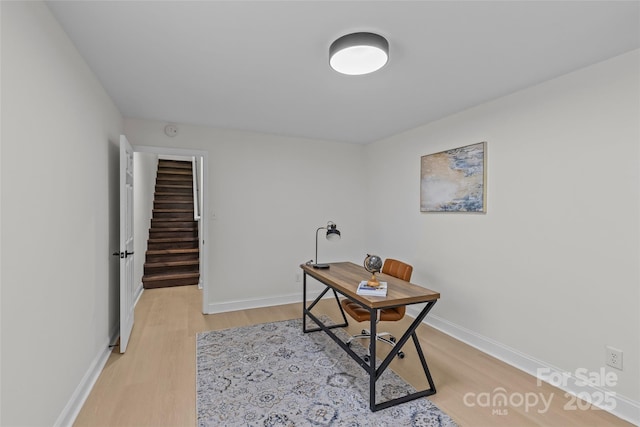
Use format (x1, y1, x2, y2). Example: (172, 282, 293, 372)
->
(49, 0, 640, 143)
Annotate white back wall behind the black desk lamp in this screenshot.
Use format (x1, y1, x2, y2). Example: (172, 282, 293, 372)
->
(125, 119, 368, 312)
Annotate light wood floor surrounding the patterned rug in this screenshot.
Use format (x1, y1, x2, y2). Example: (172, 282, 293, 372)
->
(74, 286, 631, 427)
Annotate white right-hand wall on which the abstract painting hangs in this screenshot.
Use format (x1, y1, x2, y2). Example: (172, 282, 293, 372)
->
(367, 51, 640, 412)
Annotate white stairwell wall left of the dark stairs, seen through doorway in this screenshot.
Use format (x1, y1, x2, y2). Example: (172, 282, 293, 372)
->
(133, 153, 158, 294)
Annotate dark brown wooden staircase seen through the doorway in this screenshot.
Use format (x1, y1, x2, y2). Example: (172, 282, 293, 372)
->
(142, 159, 200, 289)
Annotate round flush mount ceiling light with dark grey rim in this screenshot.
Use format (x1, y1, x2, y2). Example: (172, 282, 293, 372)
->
(329, 33, 389, 76)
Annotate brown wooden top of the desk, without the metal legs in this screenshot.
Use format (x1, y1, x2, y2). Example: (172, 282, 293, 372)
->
(300, 262, 440, 309)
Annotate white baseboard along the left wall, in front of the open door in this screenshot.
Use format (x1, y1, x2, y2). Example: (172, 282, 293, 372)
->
(53, 327, 120, 427)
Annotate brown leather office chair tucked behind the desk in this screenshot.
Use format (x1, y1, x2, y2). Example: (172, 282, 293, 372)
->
(340, 258, 413, 362)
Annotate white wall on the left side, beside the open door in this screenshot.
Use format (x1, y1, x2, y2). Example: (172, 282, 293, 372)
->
(0, 2, 122, 426)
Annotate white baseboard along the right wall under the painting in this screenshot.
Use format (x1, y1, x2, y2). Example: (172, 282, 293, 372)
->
(407, 306, 640, 425)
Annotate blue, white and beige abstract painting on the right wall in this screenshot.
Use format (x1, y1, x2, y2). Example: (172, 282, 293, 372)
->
(420, 142, 487, 212)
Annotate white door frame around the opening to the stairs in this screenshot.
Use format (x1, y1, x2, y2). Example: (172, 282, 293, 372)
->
(133, 145, 209, 314)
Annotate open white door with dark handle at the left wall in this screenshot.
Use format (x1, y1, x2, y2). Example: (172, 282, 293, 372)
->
(120, 135, 135, 353)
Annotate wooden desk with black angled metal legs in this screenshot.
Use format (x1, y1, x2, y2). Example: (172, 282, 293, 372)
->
(300, 262, 440, 411)
